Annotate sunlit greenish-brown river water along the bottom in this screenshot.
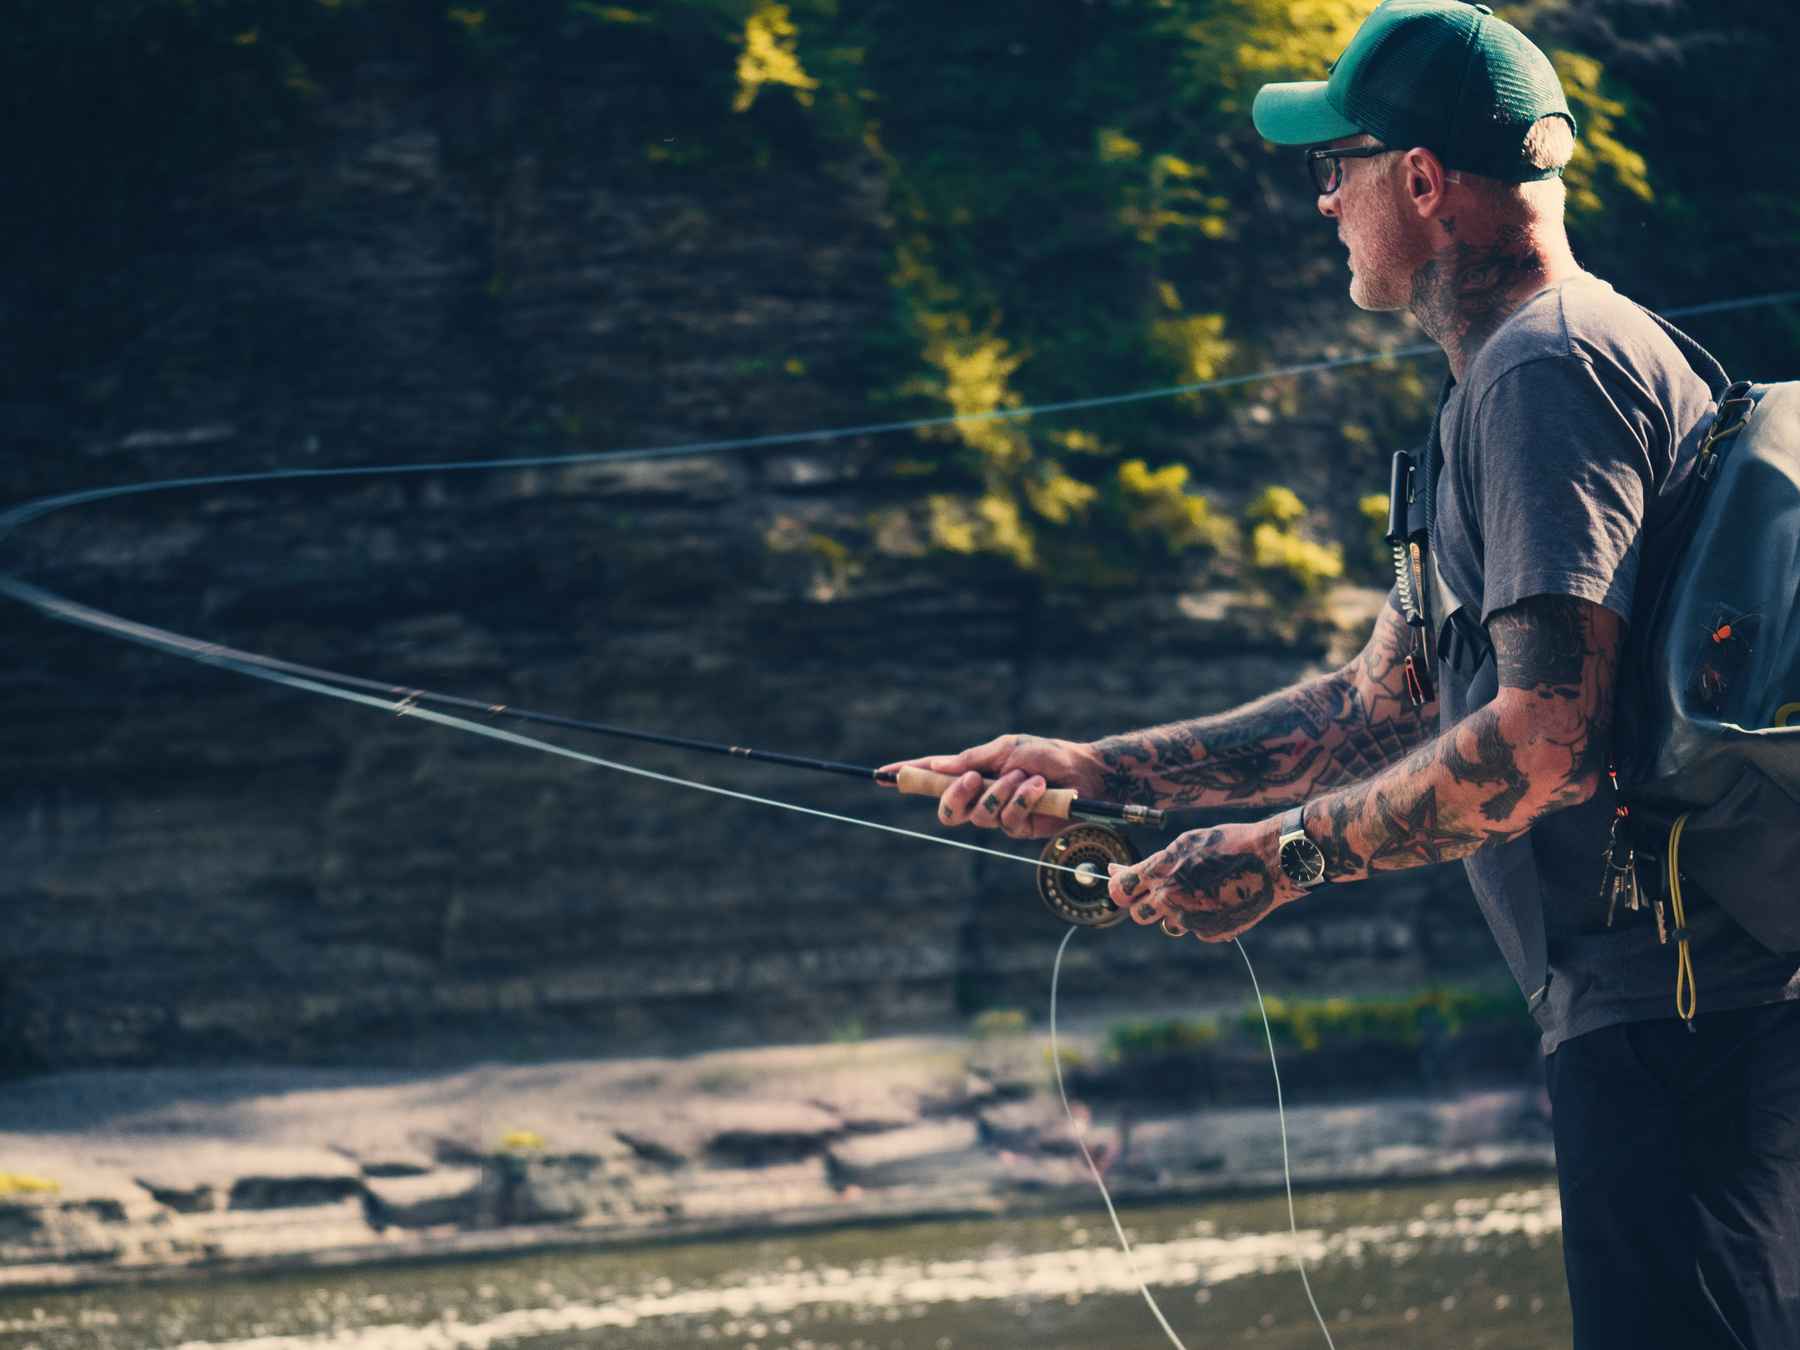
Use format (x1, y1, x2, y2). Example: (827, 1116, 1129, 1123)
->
(0, 1175, 1570, 1350)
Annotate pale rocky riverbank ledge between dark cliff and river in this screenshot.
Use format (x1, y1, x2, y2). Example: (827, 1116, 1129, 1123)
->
(0, 1035, 1552, 1289)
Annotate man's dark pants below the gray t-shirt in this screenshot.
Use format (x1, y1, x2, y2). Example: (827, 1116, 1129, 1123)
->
(1546, 1003, 1800, 1350)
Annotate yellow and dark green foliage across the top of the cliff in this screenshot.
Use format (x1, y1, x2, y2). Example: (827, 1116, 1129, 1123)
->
(10, 0, 1800, 596)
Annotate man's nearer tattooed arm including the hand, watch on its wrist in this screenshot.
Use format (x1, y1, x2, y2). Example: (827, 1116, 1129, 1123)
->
(1111, 596, 1624, 941)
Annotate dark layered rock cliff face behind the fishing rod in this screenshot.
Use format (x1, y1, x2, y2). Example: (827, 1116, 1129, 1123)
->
(0, 52, 1496, 1067)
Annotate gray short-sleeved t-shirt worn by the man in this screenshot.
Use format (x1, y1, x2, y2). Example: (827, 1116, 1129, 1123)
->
(1431, 275, 1800, 1053)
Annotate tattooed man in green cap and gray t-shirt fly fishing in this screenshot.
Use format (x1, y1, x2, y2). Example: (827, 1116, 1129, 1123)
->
(885, 0, 1800, 1350)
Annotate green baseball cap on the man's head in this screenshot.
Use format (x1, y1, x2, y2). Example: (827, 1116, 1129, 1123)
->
(1251, 0, 1575, 184)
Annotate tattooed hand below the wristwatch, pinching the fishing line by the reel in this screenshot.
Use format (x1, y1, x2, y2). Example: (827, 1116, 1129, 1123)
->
(1107, 821, 1305, 941)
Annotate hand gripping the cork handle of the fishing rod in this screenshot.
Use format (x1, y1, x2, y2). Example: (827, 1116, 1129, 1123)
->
(878, 736, 1102, 839)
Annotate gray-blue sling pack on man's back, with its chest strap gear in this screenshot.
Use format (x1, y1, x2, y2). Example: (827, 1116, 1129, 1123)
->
(1390, 325, 1800, 1019)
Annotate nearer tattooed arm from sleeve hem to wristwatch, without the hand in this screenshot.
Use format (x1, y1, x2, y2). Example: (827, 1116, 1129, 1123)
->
(1307, 598, 1620, 880)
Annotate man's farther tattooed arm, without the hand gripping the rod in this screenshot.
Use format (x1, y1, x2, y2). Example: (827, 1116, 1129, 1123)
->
(1093, 594, 1438, 806)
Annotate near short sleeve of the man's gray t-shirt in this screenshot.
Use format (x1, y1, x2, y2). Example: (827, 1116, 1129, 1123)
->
(1469, 356, 1654, 623)
